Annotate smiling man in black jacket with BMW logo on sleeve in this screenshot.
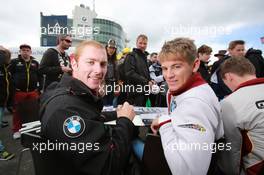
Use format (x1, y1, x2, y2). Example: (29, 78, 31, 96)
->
(41, 41, 138, 175)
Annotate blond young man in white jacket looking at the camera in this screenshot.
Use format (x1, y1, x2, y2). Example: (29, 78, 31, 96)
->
(151, 38, 223, 175)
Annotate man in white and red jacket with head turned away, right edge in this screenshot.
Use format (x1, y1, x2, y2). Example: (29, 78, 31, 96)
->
(218, 57, 264, 175)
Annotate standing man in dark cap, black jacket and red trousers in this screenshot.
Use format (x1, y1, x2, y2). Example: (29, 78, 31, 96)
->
(9, 44, 40, 139)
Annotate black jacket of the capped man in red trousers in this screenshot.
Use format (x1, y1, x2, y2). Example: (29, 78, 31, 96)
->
(9, 55, 40, 92)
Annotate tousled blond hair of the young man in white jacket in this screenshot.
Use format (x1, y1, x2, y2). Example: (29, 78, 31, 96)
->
(159, 38, 197, 64)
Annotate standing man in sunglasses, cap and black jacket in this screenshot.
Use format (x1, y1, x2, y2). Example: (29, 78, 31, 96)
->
(39, 35, 72, 90)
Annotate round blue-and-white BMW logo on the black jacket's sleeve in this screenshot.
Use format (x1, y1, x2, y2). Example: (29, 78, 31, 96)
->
(63, 115, 85, 138)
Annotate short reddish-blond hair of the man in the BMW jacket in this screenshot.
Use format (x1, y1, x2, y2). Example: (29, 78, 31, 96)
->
(74, 40, 105, 61)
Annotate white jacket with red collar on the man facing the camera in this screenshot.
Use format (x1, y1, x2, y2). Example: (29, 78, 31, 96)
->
(159, 73, 224, 175)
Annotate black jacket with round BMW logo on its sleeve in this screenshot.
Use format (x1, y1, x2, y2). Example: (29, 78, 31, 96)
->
(41, 74, 134, 175)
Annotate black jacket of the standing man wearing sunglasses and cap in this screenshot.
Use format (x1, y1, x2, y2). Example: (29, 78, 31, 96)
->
(39, 48, 70, 88)
